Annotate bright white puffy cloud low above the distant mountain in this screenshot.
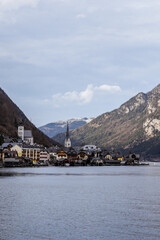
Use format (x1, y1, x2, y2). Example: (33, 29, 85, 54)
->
(52, 84, 121, 107)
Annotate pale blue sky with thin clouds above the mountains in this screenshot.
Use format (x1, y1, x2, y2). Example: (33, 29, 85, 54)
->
(0, 0, 160, 127)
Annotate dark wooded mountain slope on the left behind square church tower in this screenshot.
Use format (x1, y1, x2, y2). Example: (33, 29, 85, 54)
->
(0, 88, 59, 147)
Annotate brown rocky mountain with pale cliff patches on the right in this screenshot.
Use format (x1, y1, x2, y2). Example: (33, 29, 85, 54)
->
(54, 85, 160, 156)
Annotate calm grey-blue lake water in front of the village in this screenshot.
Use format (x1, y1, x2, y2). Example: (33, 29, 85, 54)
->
(0, 164, 160, 240)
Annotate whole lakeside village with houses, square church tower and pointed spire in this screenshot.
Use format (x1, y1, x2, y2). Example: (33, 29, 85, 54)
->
(0, 124, 140, 167)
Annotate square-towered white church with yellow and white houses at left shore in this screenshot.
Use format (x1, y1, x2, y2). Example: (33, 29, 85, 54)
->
(0, 126, 49, 167)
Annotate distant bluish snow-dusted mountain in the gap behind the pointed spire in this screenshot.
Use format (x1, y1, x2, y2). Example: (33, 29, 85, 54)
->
(39, 118, 93, 137)
